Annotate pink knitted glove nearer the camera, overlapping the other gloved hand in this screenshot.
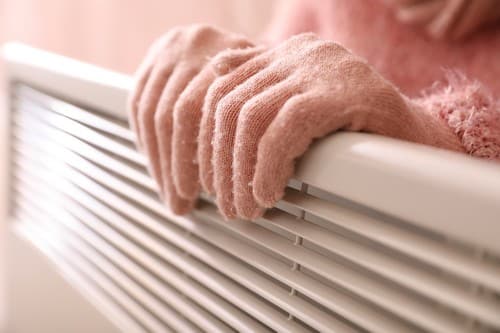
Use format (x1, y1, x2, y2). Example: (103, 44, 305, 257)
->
(199, 34, 463, 218)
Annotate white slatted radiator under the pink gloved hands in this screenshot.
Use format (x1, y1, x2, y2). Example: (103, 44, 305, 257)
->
(4, 44, 500, 333)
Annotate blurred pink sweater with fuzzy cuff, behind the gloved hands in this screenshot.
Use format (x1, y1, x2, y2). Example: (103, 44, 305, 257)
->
(269, 0, 500, 160)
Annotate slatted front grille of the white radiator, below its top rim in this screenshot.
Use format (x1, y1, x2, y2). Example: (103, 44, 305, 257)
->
(11, 84, 500, 333)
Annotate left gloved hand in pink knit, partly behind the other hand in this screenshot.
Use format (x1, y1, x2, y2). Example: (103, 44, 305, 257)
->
(129, 25, 262, 214)
